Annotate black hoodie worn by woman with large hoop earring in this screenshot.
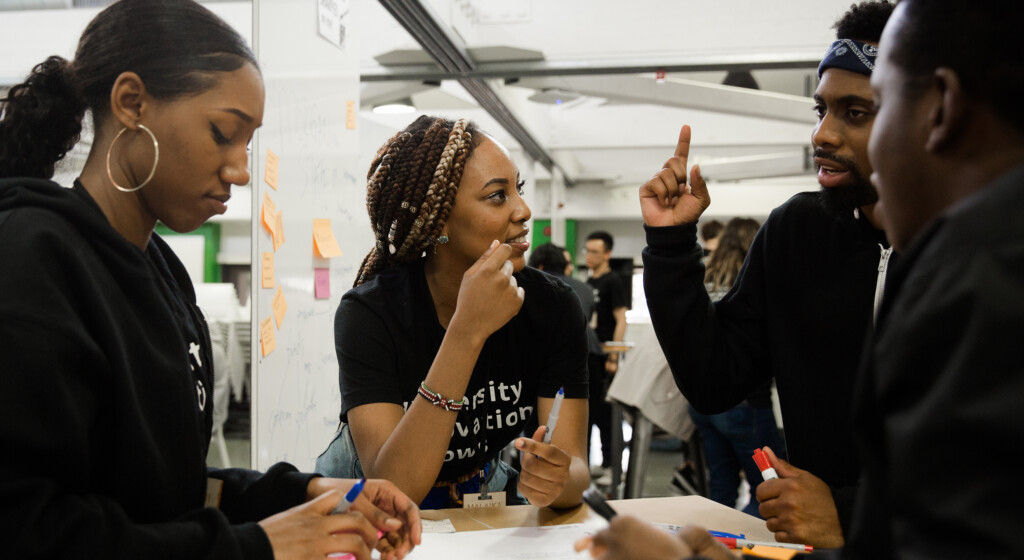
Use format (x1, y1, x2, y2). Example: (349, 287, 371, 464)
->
(0, 178, 313, 560)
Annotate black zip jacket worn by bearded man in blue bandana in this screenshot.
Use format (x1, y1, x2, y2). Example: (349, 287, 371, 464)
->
(643, 192, 887, 533)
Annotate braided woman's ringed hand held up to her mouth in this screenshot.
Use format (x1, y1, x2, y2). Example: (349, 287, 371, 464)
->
(452, 240, 525, 338)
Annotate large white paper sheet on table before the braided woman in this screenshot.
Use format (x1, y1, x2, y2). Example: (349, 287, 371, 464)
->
(407, 520, 607, 560)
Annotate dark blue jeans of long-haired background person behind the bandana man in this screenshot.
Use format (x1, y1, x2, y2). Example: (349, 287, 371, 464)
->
(690, 402, 785, 517)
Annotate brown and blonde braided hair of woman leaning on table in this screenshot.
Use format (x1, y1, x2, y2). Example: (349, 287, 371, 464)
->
(355, 116, 482, 286)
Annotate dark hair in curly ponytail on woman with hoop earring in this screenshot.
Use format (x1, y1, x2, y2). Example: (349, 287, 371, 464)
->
(0, 0, 259, 178)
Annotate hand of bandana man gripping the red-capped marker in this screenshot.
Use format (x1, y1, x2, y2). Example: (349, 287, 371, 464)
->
(757, 447, 843, 549)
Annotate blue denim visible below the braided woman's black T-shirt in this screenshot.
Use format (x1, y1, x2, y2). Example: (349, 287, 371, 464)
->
(316, 424, 526, 510)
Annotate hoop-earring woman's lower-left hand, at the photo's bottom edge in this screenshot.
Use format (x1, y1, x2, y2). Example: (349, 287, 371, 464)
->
(259, 490, 377, 560)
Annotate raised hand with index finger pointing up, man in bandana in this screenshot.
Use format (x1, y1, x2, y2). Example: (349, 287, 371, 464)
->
(640, 125, 711, 227)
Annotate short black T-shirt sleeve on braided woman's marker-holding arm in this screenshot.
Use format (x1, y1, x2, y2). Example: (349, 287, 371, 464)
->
(540, 286, 590, 398)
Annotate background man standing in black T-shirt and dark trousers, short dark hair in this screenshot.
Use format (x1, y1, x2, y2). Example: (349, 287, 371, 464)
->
(584, 231, 629, 485)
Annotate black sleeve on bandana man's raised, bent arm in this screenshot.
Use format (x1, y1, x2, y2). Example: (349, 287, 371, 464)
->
(643, 224, 770, 414)
